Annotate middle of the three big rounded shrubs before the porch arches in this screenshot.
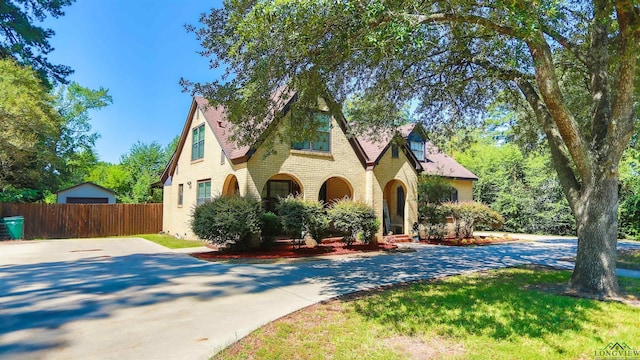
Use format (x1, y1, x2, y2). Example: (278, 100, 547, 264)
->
(276, 195, 330, 243)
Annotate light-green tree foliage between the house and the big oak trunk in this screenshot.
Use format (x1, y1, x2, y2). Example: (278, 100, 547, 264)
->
(456, 138, 576, 235)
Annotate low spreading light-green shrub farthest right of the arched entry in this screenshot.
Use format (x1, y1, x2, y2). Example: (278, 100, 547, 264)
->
(442, 201, 504, 239)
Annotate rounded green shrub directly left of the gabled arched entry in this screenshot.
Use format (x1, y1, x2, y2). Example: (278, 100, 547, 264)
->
(328, 199, 380, 245)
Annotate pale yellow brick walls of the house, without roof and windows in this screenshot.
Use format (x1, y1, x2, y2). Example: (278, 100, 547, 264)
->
(163, 97, 472, 239)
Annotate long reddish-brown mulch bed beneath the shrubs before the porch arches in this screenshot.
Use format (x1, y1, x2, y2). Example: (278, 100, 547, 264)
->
(191, 242, 397, 260)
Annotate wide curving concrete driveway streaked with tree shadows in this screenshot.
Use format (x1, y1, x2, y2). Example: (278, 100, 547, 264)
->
(0, 239, 640, 360)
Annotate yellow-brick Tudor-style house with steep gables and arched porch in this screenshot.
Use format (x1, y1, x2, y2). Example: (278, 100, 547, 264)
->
(161, 97, 477, 239)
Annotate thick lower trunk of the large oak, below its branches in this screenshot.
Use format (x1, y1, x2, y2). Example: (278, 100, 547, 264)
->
(569, 173, 619, 296)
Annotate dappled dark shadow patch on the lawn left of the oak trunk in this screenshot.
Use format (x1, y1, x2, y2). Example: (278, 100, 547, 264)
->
(354, 269, 600, 340)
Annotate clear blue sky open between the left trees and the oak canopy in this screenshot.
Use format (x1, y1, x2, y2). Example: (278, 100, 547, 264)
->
(43, 0, 221, 163)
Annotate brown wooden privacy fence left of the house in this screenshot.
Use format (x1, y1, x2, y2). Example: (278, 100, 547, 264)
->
(0, 203, 162, 239)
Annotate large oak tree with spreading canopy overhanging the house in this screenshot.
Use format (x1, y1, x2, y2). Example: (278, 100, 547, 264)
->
(191, 0, 640, 295)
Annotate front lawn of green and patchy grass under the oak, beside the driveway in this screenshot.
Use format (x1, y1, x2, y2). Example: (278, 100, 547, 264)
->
(214, 269, 640, 359)
